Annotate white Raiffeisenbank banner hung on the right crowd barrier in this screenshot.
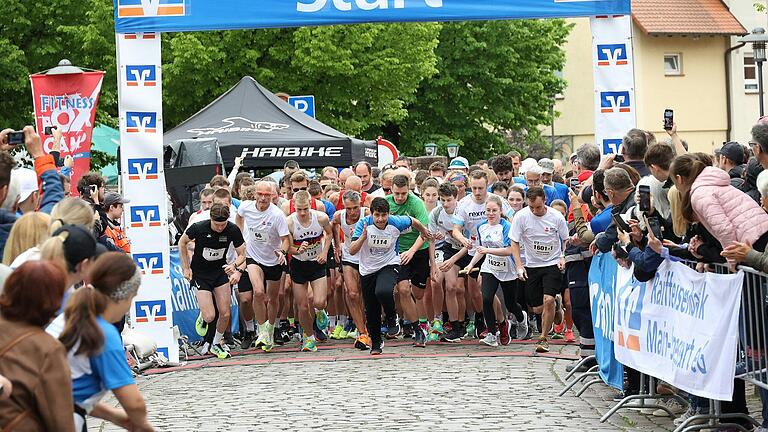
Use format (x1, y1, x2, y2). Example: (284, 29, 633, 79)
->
(614, 260, 744, 401)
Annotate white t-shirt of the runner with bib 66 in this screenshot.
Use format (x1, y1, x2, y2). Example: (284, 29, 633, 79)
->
(237, 201, 288, 266)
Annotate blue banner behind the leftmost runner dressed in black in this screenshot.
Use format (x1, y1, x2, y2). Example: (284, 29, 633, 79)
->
(170, 247, 240, 342)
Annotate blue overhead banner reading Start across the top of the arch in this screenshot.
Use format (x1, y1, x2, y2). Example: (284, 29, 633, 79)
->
(114, 0, 630, 33)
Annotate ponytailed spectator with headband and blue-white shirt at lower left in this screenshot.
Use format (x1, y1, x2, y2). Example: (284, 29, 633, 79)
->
(59, 252, 153, 431)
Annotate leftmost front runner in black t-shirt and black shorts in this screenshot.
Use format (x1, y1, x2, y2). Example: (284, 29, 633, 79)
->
(179, 203, 245, 358)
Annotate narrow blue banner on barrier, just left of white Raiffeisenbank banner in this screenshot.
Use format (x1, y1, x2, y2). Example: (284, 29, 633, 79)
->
(589, 253, 624, 390)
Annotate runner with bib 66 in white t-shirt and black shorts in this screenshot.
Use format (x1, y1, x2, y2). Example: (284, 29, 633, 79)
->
(237, 180, 290, 351)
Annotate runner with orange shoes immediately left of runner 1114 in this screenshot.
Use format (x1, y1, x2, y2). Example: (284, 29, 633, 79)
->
(332, 190, 371, 350)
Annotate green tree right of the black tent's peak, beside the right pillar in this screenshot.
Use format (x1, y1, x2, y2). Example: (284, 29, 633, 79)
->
(385, 20, 570, 160)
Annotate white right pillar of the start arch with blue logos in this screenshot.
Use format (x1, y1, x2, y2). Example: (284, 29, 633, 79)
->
(590, 15, 637, 154)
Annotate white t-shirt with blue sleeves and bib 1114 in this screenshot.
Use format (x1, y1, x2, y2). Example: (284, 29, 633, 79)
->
(352, 216, 412, 276)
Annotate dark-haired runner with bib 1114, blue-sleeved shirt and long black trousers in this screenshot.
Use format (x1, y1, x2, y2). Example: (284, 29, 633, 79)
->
(349, 197, 430, 355)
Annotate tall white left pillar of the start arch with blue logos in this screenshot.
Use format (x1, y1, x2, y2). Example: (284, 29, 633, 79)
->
(116, 33, 179, 362)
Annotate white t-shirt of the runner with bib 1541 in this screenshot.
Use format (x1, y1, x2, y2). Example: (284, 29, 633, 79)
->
(510, 206, 568, 268)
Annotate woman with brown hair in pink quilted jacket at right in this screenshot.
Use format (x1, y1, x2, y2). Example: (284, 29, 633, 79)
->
(670, 153, 768, 252)
